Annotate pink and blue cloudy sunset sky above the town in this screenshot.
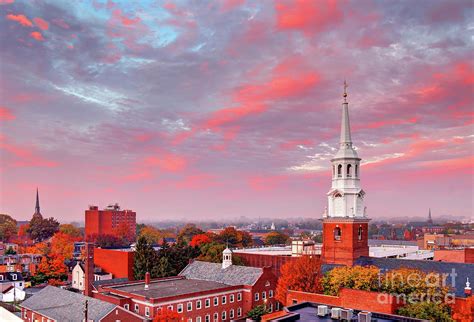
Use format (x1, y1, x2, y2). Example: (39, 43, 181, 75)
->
(0, 0, 474, 222)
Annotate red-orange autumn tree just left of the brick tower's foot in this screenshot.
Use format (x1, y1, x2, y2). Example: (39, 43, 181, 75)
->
(276, 256, 321, 303)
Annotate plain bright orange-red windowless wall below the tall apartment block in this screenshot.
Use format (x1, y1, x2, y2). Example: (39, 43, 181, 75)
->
(94, 248, 134, 281)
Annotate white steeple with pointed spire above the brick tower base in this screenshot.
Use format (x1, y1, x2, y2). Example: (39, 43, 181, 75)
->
(323, 81, 366, 218)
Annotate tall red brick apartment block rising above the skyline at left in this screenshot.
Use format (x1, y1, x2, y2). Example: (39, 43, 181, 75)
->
(85, 204, 137, 239)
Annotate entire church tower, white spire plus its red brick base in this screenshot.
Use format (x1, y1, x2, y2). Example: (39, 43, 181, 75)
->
(322, 81, 370, 266)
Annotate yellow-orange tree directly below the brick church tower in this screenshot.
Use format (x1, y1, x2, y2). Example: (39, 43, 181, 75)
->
(321, 266, 380, 295)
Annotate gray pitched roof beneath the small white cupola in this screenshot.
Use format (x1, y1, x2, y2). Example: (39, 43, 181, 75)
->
(179, 261, 263, 285)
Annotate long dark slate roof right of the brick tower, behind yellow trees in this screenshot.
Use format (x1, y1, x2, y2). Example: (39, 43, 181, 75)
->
(355, 256, 474, 297)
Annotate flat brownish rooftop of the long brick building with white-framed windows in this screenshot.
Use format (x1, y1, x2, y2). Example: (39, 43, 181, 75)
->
(109, 278, 229, 299)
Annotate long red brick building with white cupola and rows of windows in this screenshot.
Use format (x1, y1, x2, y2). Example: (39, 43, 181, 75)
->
(93, 249, 279, 322)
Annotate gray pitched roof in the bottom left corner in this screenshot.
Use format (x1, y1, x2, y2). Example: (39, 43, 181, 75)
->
(21, 286, 116, 322)
